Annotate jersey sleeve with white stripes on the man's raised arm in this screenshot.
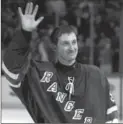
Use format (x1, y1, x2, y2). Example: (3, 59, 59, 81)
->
(2, 30, 31, 88)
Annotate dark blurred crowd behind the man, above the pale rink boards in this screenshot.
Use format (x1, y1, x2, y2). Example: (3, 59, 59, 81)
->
(1, 0, 123, 72)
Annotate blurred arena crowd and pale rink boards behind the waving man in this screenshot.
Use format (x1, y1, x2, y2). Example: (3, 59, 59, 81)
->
(1, 0, 123, 123)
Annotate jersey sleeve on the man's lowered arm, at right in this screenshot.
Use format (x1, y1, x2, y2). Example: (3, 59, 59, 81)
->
(87, 66, 118, 123)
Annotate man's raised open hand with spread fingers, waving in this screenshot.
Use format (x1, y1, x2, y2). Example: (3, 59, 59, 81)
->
(18, 2, 44, 31)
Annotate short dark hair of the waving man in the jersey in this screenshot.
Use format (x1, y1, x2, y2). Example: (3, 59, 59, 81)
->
(51, 25, 77, 45)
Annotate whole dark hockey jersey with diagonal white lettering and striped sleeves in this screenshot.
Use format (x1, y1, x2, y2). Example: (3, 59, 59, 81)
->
(2, 31, 117, 123)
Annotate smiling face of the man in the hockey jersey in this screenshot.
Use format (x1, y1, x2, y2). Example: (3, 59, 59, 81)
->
(56, 32, 78, 62)
